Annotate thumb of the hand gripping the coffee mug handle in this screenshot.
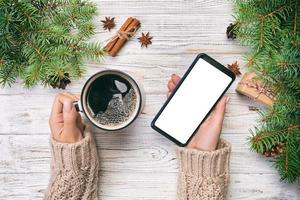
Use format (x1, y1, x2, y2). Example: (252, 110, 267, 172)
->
(63, 100, 78, 131)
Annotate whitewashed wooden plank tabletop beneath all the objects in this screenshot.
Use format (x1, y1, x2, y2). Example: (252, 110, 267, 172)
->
(0, 0, 300, 200)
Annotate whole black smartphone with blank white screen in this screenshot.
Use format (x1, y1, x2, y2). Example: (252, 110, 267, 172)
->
(151, 54, 235, 146)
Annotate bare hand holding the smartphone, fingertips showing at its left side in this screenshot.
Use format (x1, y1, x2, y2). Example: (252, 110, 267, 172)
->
(167, 74, 229, 151)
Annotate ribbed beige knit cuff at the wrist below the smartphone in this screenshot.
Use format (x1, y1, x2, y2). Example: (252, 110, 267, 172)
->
(177, 139, 231, 177)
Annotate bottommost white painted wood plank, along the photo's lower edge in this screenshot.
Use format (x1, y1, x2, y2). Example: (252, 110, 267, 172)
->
(0, 172, 300, 200)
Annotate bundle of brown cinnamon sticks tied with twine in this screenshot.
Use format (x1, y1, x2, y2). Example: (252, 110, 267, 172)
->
(104, 17, 140, 57)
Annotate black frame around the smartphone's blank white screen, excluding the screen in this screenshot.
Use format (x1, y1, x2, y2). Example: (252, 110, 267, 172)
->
(151, 53, 235, 147)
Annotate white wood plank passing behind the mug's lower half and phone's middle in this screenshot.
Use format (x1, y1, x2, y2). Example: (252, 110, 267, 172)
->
(0, 91, 257, 134)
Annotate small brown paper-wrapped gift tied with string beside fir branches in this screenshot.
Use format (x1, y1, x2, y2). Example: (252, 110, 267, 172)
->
(236, 72, 275, 106)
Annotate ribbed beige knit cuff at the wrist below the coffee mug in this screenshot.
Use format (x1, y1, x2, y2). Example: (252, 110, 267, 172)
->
(51, 128, 98, 174)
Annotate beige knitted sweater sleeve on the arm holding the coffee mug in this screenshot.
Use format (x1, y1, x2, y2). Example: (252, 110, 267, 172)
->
(44, 131, 99, 200)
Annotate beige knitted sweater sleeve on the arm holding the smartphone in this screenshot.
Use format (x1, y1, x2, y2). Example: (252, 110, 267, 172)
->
(177, 139, 230, 200)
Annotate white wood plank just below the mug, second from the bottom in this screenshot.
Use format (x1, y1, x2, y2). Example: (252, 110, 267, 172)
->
(0, 134, 290, 174)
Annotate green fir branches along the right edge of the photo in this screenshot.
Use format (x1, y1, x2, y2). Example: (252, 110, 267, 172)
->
(234, 0, 300, 183)
